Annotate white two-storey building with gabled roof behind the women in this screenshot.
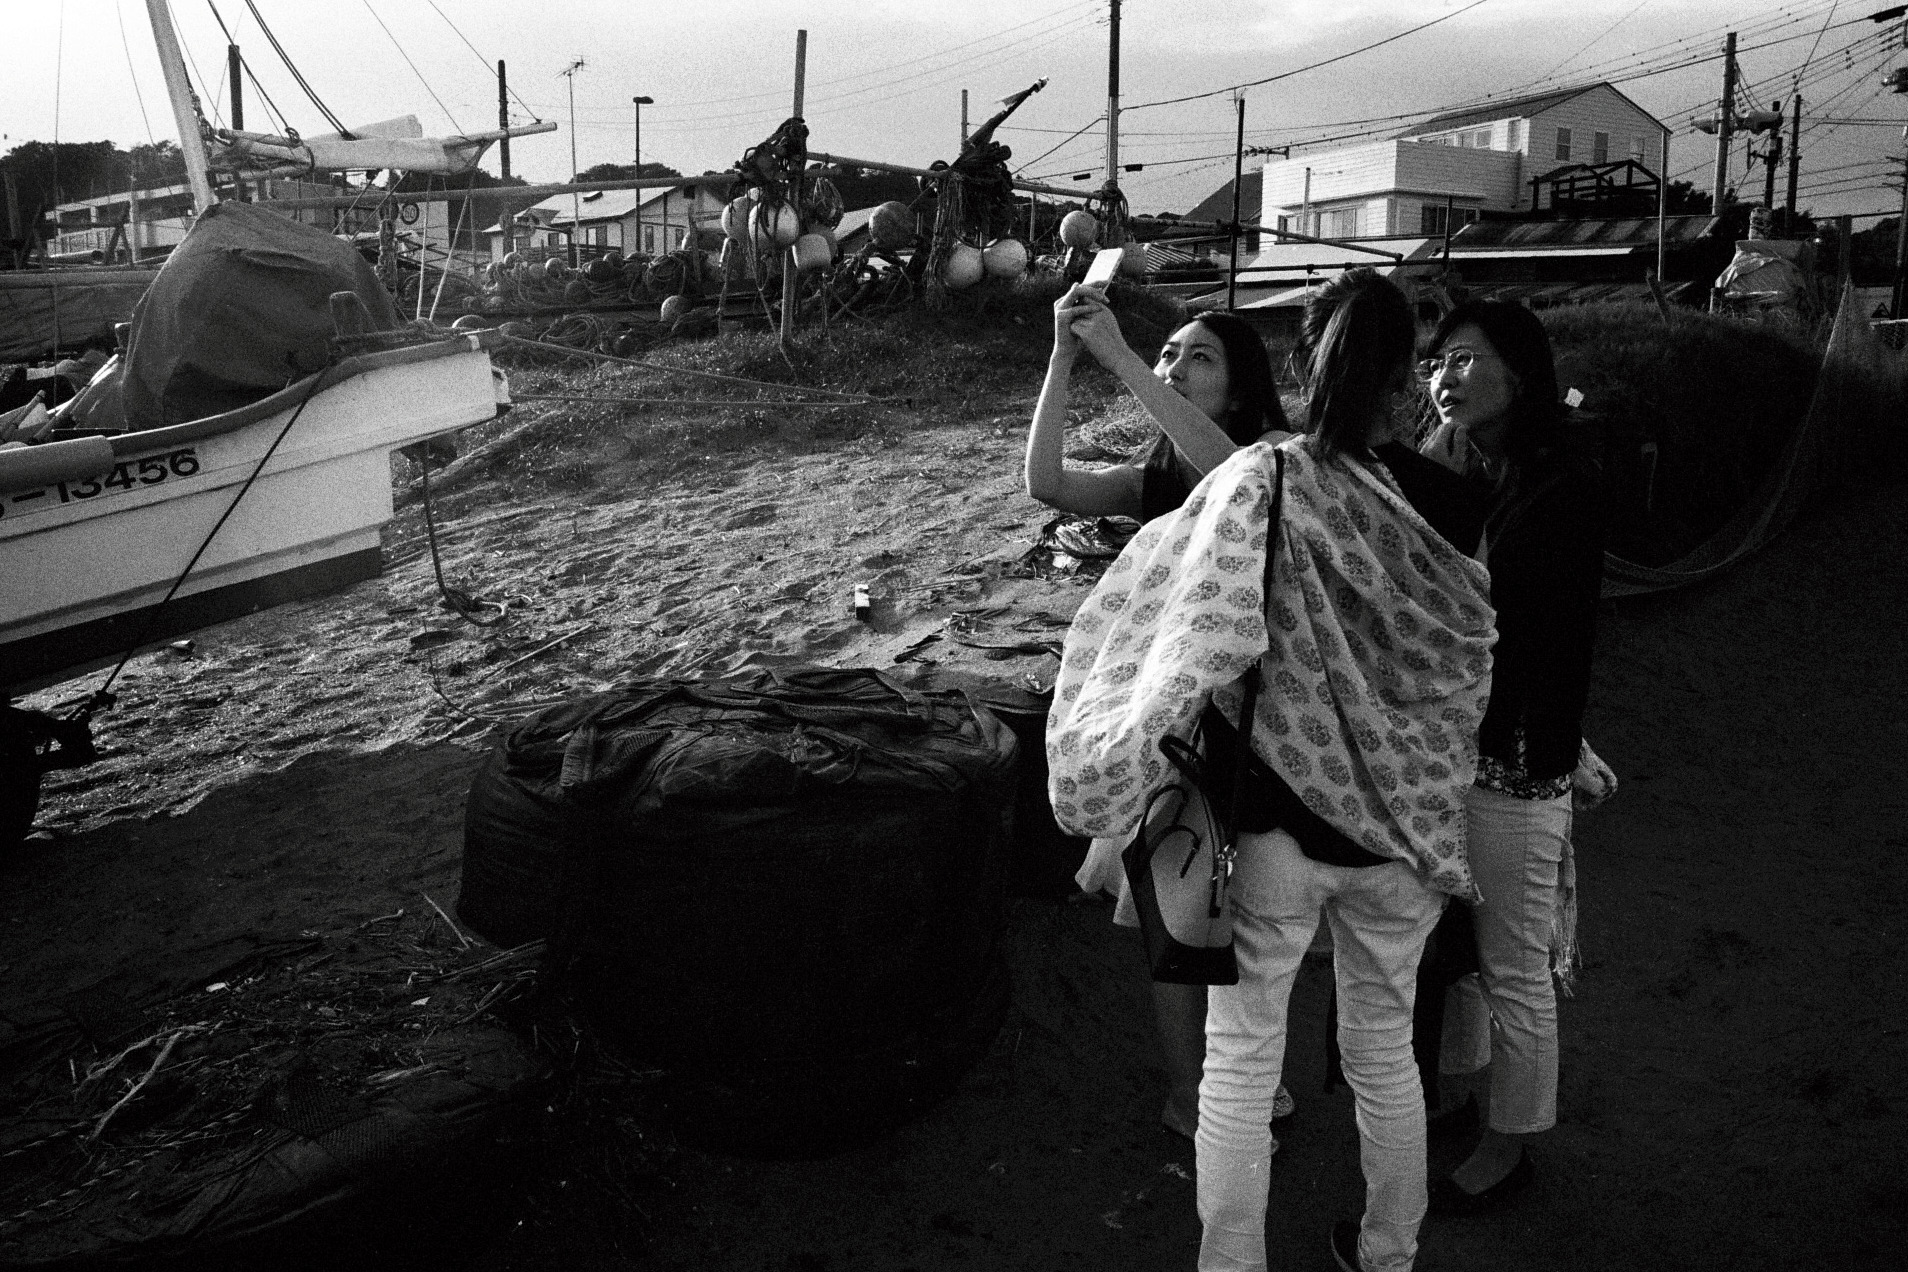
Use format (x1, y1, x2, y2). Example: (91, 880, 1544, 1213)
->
(1261, 84, 1664, 238)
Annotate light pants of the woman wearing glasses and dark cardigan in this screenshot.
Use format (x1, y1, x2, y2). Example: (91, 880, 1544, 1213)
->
(1439, 786, 1570, 1135)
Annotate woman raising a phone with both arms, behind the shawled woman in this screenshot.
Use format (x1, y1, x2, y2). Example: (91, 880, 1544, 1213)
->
(1025, 284, 1294, 1139)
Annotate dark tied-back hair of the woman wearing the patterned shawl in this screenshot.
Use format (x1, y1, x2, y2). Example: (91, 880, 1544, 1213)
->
(1299, 265, 1418, 458)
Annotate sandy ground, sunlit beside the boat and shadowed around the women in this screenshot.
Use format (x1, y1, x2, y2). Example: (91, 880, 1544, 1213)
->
(0, 352, 1908, 1272)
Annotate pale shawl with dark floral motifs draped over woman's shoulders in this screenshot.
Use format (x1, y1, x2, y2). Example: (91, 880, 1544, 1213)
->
(1047, 437, 1498, 898)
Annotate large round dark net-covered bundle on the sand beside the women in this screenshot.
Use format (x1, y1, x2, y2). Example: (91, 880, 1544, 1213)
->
(458, 667, 1017, 1156)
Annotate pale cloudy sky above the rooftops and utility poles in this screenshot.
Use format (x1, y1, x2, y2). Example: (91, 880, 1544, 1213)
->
(11, 0, 1908, 214)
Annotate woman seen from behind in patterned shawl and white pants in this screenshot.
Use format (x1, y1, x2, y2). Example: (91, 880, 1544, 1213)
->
(1047, 269, 1496, 1272)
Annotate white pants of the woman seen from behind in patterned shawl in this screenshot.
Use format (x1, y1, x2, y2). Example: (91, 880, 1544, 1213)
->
(1194, 831, 1444, 1272)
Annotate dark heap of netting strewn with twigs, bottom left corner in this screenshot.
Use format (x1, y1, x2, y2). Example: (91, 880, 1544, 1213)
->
(0, 908, 551, 1268)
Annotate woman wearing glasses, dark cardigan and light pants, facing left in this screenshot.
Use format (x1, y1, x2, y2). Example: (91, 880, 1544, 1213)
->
(1420, 301, 1605, 1213)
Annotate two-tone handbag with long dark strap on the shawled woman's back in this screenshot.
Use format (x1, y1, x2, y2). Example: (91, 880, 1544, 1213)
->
(1120, 450, 1286, 984)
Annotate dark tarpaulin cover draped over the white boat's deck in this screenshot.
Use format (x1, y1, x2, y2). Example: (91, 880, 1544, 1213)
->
(122, 202, 399, 429)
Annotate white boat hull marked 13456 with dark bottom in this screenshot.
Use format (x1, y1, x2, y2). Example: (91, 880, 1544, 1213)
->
(0, 332, 509, 692)
